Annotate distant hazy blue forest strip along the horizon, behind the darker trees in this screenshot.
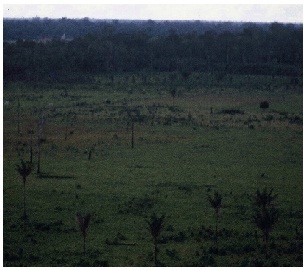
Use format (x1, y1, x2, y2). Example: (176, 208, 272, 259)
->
(3, 17, 296, 40)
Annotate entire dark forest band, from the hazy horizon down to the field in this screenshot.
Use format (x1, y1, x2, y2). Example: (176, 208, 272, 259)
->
(3, 18, 303, 81)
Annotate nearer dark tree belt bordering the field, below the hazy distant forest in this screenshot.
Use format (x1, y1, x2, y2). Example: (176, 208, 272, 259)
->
(3, 23, 303, 80)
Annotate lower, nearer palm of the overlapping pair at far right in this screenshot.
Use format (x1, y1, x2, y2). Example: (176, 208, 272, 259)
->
(253, 207, 278, 258)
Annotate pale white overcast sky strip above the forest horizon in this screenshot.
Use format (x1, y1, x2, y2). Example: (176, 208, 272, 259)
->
(3, 4, 303, 23)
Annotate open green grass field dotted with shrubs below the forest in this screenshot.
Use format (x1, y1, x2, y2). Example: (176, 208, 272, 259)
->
(3, 74, 303, 266)
